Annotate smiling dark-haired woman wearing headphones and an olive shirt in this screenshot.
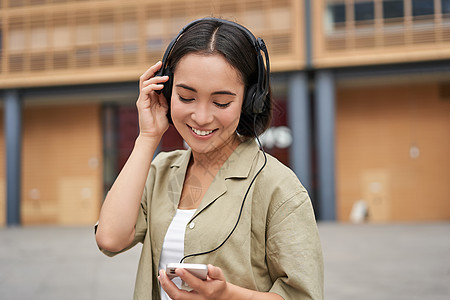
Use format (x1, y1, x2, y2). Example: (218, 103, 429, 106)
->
(96, 18, 323, 299)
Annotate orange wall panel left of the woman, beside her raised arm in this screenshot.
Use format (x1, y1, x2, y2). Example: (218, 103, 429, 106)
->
(21, 104, 102, 225)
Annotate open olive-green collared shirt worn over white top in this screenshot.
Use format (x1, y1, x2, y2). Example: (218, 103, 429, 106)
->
(98, 139, 323, 300)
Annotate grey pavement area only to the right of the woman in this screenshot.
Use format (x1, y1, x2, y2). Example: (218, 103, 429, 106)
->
(319, 223, 450, 300)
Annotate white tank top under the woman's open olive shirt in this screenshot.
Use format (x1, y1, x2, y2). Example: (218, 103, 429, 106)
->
(158, 209, 196, 300)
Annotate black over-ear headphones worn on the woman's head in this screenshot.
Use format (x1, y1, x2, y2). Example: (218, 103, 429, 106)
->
(156, 18, 270, 123)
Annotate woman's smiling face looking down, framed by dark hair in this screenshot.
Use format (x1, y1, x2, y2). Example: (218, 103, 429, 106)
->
(171, 53, 245, 153)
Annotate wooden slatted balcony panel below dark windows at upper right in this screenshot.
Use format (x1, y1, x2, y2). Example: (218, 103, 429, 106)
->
(312, 0, 450, 67)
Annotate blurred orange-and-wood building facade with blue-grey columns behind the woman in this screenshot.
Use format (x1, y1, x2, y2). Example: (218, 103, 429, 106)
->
(0, 0, 450, 225)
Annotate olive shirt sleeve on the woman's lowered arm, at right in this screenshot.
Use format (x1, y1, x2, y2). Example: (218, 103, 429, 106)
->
(266, 189, 324, 300)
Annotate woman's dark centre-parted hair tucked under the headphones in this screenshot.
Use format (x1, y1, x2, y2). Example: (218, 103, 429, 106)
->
(167, 18, 272, 137)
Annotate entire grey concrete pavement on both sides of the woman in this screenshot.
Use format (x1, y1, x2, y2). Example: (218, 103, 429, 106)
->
(0, 222, 450, 300)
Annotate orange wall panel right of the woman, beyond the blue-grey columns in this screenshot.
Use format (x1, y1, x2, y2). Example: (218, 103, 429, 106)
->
(336, 84, 450, 221)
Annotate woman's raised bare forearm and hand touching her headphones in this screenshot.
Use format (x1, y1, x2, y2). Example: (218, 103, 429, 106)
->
(96, 62, 169, 252)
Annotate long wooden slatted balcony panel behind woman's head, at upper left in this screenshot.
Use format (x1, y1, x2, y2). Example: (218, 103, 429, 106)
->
(0, 0, 305, 88)
